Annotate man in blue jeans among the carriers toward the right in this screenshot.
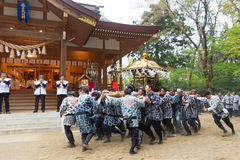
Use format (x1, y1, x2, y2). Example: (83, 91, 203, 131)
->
(169, 88, 184, 135)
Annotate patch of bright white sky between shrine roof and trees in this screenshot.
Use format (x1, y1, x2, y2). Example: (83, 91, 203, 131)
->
(73, 0, 157, 24)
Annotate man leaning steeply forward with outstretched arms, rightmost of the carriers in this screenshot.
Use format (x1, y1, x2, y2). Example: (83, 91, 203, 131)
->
(198, 91, 235, 136)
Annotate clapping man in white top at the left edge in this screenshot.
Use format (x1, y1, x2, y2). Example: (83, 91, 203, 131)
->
(0, 72, 11, 114)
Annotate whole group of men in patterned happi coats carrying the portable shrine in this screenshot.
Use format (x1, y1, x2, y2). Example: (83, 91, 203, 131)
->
(60, 84, 235, 154)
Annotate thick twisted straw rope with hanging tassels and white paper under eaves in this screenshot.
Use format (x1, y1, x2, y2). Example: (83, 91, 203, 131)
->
(0, 40, 53, 59)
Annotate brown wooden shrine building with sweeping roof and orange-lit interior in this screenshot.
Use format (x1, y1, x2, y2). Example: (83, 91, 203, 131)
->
(0, 0, 160, 89)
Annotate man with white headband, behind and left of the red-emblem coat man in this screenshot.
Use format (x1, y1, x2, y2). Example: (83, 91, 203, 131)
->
(98, 90, 125, 143)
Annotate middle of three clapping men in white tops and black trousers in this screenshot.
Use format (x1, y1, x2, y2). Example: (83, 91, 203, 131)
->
(33, 75, 47, 113)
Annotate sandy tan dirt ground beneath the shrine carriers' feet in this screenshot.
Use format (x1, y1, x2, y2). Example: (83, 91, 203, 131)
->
(0, 113, 240, 160)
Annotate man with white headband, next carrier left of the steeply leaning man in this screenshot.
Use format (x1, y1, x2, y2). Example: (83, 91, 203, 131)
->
(176, 88, 199, 136)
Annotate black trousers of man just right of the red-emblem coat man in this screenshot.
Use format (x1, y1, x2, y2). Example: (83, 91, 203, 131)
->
(145, 118, 162, 141)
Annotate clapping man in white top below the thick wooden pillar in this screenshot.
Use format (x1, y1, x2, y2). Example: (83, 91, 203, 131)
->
(56, 75, 68, 112)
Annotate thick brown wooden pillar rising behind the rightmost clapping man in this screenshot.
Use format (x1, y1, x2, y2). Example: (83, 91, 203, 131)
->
(60, 39, 67, 77)
